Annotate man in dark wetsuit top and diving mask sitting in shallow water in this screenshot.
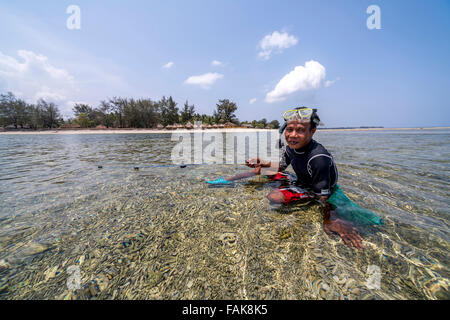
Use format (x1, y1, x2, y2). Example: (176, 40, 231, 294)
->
(246, 107, 363, 249)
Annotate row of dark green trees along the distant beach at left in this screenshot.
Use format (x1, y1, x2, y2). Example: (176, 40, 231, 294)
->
(0, 92, 280, 130)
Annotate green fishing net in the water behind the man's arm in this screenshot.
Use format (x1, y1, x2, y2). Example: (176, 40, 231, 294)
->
(327, 185, 384, 225)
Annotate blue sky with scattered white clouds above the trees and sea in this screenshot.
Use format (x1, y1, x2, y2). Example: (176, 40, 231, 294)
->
(0, 0, 450, 127)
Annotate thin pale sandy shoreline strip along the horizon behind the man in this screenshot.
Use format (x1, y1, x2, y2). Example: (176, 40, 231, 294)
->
(0, 127, 450, 134)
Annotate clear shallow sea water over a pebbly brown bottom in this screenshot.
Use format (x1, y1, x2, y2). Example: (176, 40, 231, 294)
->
(0, 130, 450, 299)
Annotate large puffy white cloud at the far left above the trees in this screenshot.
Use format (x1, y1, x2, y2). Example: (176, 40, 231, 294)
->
(0, 50, 78, 109)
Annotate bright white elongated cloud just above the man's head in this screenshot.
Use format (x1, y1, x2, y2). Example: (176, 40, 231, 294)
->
(265, 60, 326, 103)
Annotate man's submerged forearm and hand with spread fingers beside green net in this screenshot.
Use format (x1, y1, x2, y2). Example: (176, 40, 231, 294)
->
(320, 197, 364, 250)
